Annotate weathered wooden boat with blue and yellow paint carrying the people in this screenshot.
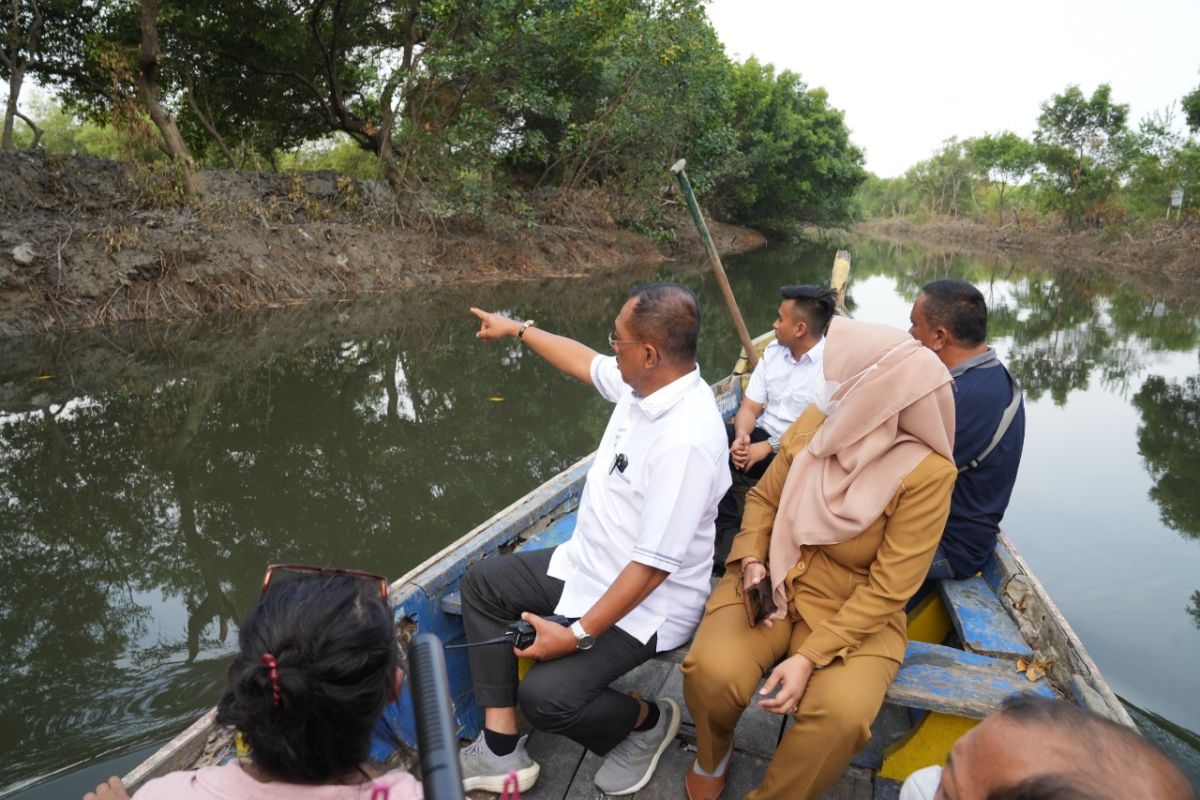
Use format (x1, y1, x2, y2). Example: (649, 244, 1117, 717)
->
(117, 253, 1134, 800)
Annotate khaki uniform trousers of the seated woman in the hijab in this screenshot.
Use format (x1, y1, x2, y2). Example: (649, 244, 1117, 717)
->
(682, 604, 900, 800)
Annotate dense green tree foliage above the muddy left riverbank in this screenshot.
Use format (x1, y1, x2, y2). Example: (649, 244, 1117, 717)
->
(9, 0, 865, 227)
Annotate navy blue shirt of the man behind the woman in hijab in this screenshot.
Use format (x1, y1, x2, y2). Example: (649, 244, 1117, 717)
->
(942, 348, 1025, 578)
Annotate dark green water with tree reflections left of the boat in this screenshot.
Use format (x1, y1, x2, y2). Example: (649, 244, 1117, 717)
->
(0, 297, 619, 787)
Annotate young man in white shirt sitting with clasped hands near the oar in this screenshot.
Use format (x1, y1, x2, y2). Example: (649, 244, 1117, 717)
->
(713, 285, 838, 575)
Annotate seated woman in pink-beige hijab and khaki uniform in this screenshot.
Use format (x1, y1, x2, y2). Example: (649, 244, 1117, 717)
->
(683, 318, 956, 800)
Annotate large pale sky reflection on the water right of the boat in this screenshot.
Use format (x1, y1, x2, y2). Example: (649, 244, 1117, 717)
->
(1004, 353, 1200, 730)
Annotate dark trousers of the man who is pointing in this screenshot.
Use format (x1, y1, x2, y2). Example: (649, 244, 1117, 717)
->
(462, 548, 658, 756)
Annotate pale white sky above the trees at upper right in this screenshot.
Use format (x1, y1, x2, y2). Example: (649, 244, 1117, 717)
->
(708, 0, 1200, 178)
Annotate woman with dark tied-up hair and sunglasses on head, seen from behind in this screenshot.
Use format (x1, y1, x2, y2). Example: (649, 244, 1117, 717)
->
(84, 566, 422, 800)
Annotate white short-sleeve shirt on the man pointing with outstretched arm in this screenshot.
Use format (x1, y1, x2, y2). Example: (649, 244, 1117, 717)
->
(548, 355, 730, 650)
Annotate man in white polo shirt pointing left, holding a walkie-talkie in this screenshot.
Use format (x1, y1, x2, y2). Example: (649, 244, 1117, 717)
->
(462, 283, 730, 794)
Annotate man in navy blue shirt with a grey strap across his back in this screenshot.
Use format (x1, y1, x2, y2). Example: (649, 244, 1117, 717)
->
(908, 278, 1025, 578)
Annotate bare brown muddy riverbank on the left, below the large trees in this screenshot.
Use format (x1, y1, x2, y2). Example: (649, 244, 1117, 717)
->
(0, 152, 766, 336)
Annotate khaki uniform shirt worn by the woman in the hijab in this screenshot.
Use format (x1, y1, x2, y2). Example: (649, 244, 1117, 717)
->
(708, 405, 958, 667)
